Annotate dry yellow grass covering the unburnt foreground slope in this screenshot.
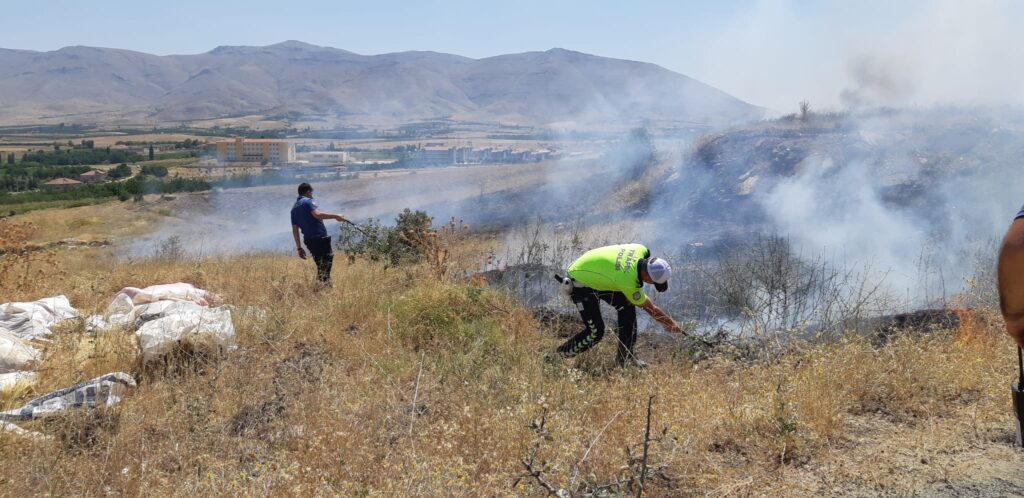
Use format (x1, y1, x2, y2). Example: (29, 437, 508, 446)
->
(0, 203, 1024, 496)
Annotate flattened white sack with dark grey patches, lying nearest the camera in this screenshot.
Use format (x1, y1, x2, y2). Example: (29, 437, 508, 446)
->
(0, 372, 136, 420)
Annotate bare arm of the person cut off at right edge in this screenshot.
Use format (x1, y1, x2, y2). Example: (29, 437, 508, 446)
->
(997, 218, 1024, 347)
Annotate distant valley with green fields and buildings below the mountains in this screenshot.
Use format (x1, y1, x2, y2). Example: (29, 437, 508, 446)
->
(0, 123, 593, 216)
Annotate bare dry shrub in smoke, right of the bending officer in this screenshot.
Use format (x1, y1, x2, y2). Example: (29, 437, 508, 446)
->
(667, 235, 895, 341)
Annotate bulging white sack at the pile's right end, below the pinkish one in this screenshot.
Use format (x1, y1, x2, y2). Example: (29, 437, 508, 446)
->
(135, 303, 236, 362)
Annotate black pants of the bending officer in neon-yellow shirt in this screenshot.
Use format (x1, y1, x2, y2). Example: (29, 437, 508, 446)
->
(558, 287, 637, 363)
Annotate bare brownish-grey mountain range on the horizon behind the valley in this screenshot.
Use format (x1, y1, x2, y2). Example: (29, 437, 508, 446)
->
(0, 41, 764, 126)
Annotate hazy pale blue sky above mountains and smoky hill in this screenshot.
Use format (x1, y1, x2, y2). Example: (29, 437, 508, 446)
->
(0, 0, 1024, 112)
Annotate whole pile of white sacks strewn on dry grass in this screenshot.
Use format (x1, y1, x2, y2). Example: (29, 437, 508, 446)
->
(0, 283, 236, 435)
